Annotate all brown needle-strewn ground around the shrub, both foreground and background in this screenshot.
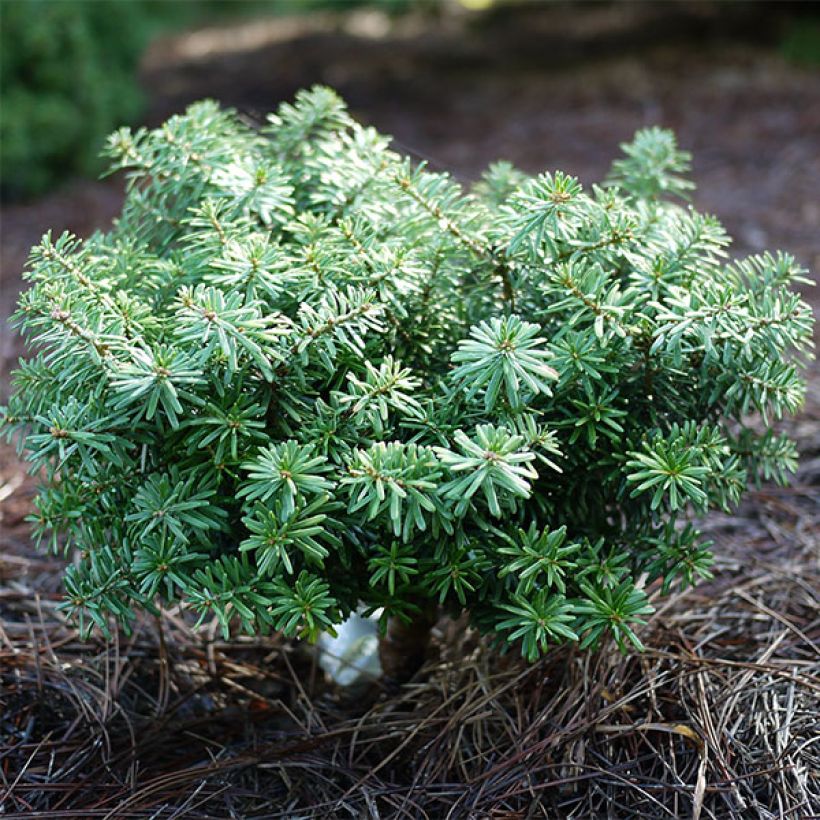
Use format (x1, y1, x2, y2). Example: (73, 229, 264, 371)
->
(0, 4, 820, 820)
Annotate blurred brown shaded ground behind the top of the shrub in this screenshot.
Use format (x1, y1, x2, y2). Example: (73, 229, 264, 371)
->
(144, 4, 820, 269)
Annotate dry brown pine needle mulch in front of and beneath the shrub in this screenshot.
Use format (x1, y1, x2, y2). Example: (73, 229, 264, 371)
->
(0, 398, 820, 820)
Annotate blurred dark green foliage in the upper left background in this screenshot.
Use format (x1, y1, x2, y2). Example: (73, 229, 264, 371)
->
(0, 0, 420, 200)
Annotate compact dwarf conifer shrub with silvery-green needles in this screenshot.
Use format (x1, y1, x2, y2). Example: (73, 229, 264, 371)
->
(5, 88, 812, 659)
